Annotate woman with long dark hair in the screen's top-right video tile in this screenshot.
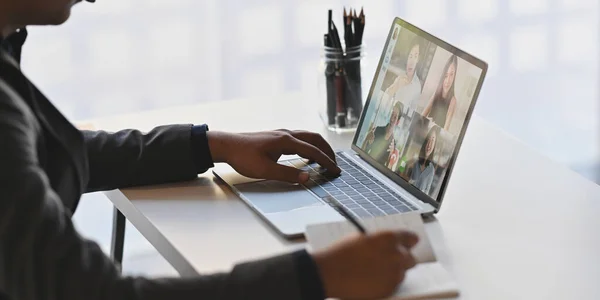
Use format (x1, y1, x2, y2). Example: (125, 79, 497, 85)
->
(423, 55, 458, 130)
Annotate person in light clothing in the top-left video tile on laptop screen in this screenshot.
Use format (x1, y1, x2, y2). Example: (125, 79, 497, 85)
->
(375, 37, 421, 126)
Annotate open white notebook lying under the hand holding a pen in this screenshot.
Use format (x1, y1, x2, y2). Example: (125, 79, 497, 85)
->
(306, 213, 459, 300)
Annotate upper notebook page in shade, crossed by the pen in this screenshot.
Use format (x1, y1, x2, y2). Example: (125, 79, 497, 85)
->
(306, 213, 436, 263)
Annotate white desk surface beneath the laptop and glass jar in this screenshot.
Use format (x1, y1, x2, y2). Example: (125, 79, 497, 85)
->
(89, 95, 600, 299)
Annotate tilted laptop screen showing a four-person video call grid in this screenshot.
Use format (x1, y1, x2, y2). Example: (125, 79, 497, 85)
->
(354, 19, 486, 201)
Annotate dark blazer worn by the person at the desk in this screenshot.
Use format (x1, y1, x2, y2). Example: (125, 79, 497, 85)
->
(0, 44, 318, 300)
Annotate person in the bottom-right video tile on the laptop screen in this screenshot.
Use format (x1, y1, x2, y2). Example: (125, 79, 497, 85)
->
(407, 126, 440, 195)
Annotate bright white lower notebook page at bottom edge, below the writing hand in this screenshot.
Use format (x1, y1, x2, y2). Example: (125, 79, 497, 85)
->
(390, 262, 459, 300)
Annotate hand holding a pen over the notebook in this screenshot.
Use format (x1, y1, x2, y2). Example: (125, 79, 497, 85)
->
(313, 231, 418, 299)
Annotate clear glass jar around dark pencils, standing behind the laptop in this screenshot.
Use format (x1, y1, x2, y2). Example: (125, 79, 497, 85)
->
(320, 45, 364, 131)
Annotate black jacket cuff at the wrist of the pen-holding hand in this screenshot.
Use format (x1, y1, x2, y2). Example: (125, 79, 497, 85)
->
(293, 250, 325, 300)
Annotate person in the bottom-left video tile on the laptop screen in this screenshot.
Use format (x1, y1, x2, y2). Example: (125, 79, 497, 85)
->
(362, 102, 402, 165)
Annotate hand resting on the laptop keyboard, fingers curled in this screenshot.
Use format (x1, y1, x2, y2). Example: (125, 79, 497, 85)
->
(206, 129, 341, 183)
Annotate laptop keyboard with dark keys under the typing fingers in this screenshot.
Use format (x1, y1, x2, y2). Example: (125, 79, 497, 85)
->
(301, 155, 418, 218)
